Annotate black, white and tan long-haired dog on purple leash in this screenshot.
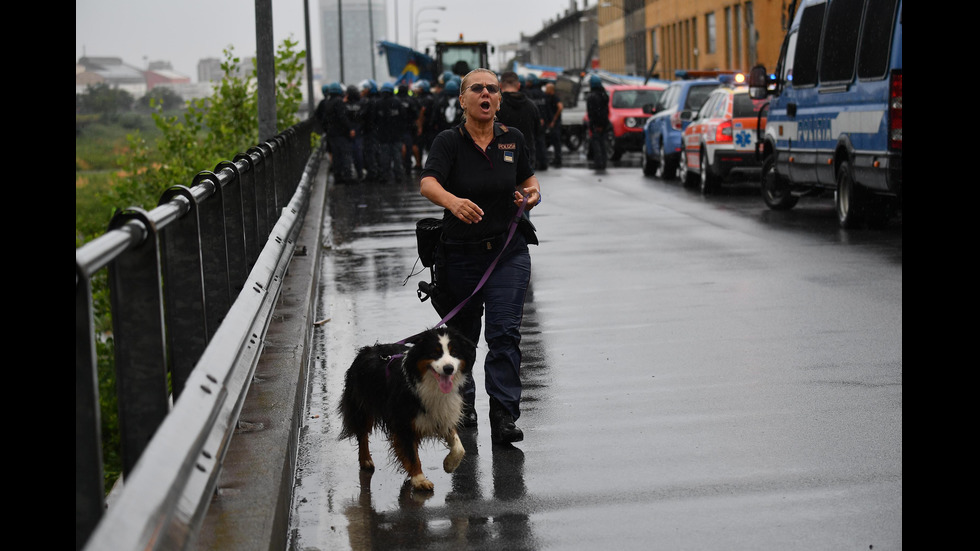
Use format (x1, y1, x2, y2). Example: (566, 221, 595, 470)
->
(337, 326, 476, 490)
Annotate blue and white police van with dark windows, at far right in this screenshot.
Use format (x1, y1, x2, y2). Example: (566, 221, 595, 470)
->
(749, 0, 902, 228)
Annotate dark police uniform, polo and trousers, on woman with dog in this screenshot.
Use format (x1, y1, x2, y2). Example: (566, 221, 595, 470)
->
(421, 123, 538, 420)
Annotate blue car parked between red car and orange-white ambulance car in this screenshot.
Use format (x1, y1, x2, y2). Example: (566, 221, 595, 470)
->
(641, 79, 722, 179)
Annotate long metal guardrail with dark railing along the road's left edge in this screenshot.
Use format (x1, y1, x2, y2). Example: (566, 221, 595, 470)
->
(75, 120, 322, 549)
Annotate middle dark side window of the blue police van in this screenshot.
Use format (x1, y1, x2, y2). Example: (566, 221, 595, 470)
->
(820, 0, 864, 82)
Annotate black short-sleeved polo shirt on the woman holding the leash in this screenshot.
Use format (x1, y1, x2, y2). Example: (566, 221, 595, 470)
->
(421, 123, 534, 242)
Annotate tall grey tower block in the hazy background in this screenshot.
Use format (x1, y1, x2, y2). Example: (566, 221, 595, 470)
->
(314, 0, 386, 91)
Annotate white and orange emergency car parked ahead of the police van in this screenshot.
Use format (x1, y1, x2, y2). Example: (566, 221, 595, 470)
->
(678, 86, 768, 194)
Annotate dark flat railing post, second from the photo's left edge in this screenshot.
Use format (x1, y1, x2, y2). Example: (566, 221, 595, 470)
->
(109, 208, 170, 476)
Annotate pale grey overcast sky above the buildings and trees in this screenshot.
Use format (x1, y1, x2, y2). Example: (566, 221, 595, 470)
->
(75, 0, 584, 82)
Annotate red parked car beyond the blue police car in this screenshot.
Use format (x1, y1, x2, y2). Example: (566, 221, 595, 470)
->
(583, 81, 668, 161)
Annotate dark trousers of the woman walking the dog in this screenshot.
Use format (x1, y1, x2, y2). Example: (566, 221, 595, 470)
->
(437, 232, 531, 420)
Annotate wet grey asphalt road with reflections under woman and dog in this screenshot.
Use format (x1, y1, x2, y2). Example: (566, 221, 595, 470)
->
(290, 152, 902, 551)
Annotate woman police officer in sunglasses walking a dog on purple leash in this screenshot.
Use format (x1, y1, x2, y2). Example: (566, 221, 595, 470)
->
(420, 69, 541, 443)
